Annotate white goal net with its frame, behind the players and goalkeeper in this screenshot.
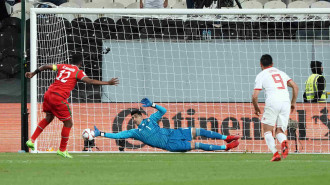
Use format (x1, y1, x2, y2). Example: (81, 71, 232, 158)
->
(31, 8, 330, 153)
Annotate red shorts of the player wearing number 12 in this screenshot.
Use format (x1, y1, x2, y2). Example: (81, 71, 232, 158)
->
(42, 91, 71, 121)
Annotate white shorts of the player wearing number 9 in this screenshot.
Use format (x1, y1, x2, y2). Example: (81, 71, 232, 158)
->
(261, 102, 291, 132)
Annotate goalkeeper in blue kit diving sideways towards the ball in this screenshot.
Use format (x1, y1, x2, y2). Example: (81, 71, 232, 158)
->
(94, 98, 240, 152)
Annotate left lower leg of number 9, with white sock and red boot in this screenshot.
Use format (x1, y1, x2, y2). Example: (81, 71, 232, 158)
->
(263, 124, 281, 161)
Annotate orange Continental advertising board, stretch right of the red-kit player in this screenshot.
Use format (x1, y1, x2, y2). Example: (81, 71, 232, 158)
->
(53, 103, 330, 153)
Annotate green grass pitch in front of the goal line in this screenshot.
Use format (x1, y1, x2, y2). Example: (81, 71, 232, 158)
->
(0, 153, 330, 185)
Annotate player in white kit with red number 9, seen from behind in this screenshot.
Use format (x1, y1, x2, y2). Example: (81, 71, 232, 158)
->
(252, 54, 298, 161)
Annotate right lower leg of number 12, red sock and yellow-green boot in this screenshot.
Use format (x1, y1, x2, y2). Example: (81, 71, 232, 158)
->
(57, 118, 73, 158)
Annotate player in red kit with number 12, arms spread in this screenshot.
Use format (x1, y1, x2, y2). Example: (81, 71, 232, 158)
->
(25, 54, 119, 158)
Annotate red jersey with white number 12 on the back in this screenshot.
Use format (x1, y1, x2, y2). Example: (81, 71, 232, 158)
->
(47, 64, 87, 99)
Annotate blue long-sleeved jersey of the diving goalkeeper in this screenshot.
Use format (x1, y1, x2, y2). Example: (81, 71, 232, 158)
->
(104, 105, 174, 149)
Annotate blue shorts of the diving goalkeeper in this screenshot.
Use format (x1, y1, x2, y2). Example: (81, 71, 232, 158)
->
(166, 127, 192, 152)
